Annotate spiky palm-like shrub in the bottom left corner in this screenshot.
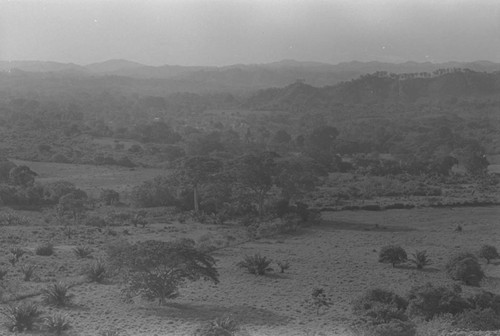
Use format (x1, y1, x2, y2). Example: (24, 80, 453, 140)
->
(2, 303, 42, 332)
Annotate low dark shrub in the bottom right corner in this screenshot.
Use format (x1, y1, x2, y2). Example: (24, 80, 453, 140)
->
(454, 308, 500, 331)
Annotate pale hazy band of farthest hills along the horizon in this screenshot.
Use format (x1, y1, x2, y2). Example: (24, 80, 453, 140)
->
(0, 60, 500, 94)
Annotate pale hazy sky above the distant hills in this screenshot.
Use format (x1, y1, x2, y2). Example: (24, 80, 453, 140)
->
(0, 0, 500, 65)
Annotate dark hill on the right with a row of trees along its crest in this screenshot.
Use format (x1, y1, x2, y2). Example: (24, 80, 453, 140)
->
(245, 69, 500, 110)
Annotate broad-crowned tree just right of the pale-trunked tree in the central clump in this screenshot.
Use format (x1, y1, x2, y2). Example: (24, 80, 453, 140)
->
(234, 152, 277, 219)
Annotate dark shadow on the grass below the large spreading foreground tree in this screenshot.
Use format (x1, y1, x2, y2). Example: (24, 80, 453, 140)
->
(143, 302, 289, 325)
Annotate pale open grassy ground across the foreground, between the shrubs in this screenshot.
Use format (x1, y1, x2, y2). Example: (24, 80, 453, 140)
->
(0, 207, 500, 336)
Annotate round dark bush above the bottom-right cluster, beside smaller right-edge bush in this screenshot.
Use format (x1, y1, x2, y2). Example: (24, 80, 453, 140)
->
(446, 253, 484, 286)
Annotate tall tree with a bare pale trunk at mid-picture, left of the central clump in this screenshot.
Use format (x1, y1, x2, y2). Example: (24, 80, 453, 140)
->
(176, 156, 222, 213)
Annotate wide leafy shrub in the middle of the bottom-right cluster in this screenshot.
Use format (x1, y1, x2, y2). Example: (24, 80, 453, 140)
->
(408, 283, 469, 320)
